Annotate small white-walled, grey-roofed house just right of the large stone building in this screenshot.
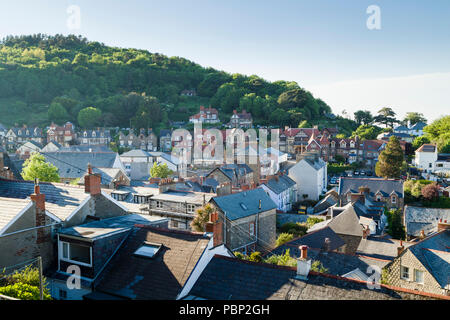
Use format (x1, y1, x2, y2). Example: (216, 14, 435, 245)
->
(261, 174, 297, 212)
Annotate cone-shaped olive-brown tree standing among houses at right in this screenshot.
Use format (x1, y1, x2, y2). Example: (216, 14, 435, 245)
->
(375, 136, 404, 178)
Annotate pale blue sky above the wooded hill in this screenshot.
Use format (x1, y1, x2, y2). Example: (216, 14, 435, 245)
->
(0, 0, 450, 121)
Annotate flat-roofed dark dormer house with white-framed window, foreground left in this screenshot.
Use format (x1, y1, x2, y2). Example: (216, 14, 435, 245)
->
(48, 214, 167, 300)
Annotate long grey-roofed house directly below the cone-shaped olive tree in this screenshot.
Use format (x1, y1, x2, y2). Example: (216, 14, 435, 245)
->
(338, 177, 404, 209)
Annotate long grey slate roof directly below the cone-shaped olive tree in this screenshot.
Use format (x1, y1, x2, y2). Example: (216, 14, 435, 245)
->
(338, 177, 403, 198)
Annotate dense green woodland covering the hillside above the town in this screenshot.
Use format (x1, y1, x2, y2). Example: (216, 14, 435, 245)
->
(0, 34, 356, 134)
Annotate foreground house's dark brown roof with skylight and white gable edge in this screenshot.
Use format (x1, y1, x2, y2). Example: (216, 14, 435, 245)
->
(83, 224, 233, 300)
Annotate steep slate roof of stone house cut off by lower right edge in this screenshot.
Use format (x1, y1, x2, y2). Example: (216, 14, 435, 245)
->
(408, 230, 450, 288)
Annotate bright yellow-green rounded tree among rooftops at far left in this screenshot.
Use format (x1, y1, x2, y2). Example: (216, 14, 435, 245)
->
(22, 152, 60, 182)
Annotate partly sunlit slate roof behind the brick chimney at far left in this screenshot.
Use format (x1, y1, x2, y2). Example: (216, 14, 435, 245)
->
(0, 179, 89, 221)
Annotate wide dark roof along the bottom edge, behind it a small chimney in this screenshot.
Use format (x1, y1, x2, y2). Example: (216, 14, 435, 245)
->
(185, 255, 436, 300)
